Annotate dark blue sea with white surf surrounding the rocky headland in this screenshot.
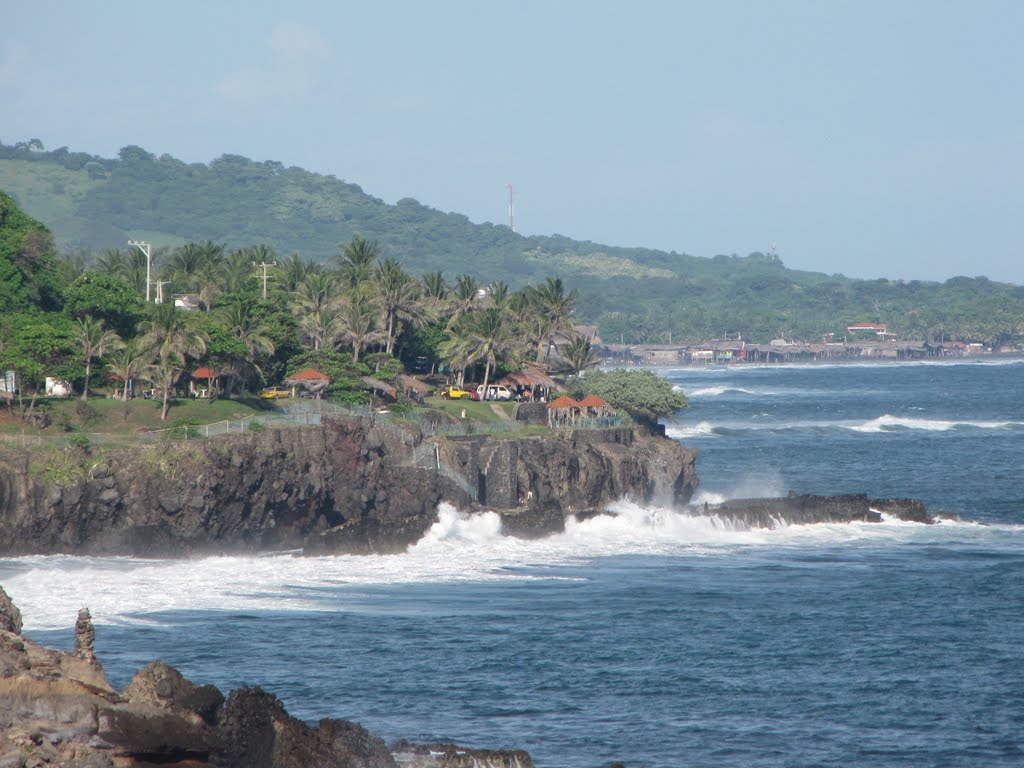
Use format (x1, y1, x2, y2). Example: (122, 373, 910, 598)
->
(0, 362, 1024, 768)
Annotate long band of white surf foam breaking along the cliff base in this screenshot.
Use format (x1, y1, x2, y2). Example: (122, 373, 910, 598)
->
(0, 501, 1024, 631)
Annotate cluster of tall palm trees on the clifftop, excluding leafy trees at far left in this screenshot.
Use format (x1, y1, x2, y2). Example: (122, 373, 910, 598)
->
(77, 236, 595, 415)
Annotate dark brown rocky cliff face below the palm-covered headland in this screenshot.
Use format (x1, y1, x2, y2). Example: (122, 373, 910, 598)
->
(0, 417, 696, 556)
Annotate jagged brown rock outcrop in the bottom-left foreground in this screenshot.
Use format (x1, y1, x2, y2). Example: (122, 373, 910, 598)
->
(0, 588, 532, 768)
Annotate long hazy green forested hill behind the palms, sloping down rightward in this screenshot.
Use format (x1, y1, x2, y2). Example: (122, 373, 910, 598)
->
(0, 140, 1024, 342)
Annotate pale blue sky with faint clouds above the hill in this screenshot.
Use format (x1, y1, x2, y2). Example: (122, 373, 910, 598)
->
(0, 0, 1024, 284)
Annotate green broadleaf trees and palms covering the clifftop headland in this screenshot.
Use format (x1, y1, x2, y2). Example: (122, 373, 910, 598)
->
(0, 193, 587, 420)
